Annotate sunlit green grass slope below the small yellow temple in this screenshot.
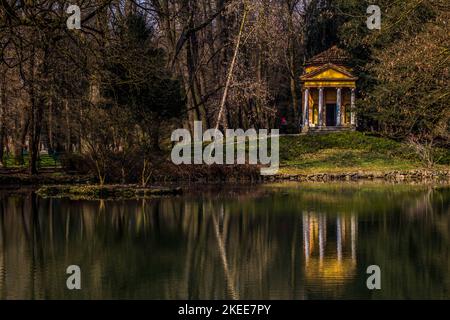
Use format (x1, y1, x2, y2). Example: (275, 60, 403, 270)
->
(280, 132, 448, 174)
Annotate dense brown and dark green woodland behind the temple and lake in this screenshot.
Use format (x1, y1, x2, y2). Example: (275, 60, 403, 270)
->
(0, 0, 450, 182)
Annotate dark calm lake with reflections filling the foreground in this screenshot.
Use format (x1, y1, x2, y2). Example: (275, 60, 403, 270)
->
(0, 183, 450, 299)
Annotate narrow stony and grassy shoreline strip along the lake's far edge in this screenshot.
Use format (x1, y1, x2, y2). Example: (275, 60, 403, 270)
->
(0, 169, 450, 200)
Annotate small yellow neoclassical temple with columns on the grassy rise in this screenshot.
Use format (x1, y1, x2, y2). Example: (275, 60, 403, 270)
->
(300, 46, 358, 132)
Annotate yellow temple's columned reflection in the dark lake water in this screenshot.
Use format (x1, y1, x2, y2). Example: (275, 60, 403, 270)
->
(303, 212, 358, 289)
